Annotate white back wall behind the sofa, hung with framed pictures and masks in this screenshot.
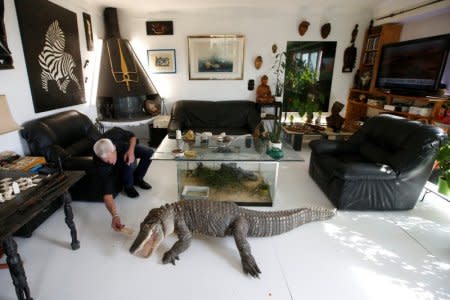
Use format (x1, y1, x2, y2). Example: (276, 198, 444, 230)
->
(118, 7, 370, 113)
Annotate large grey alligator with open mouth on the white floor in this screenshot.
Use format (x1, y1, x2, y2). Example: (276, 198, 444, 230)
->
(130, 200, 336, 278)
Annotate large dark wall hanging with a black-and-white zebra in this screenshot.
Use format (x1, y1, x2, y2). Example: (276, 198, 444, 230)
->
(15, 0, 85, 113)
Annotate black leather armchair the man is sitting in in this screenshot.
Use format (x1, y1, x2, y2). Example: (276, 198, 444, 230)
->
(21, 110, 122, 201)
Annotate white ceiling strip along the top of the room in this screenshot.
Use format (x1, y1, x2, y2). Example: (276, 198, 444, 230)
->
(79, 0, 450, 21)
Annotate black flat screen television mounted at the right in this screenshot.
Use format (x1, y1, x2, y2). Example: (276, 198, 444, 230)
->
(376, 34, 450, 96)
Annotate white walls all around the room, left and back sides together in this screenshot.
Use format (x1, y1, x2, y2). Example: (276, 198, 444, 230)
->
(0, 0, 449, 154)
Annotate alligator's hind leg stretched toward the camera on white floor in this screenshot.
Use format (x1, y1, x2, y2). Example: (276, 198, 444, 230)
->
(232, 217, 261, 278)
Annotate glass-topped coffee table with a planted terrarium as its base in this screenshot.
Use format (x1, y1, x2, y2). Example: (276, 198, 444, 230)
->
(152, 135, 304, 206)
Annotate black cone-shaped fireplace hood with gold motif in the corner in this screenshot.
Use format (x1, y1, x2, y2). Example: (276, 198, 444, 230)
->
(97, 7, 161, 122)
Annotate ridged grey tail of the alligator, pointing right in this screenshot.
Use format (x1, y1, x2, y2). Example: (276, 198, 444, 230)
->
(241, 207, 336, 237)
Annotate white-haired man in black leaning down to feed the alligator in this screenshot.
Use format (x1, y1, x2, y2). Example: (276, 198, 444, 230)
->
(94, 127, 153, 231)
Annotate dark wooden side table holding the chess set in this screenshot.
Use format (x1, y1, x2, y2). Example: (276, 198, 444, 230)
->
(0, 171, 84, 300)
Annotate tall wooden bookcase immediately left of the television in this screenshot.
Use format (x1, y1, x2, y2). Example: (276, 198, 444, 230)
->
(358, 23, 402, 93)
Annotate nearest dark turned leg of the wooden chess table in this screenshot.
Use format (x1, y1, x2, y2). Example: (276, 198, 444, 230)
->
(3, 236, 33, 300)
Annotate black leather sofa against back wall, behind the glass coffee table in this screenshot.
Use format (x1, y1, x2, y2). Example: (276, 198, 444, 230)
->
(167, 100, 260, 138)
